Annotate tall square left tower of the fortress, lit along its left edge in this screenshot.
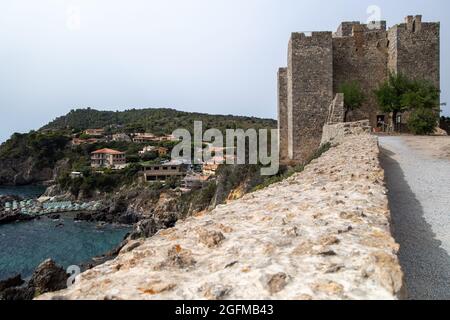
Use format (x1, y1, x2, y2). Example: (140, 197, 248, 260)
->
(287, 32, 333, 163)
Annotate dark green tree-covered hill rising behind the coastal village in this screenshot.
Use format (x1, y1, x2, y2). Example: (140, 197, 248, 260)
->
(0, 108, 277, 189)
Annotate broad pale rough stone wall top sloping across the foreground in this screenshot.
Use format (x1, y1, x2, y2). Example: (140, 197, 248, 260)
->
(40, 134, 404, 299)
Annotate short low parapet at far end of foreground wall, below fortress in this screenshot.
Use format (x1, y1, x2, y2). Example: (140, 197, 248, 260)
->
(321, 120, 372, 145)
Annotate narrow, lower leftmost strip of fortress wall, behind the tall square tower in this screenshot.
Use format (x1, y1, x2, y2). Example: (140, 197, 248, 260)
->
(278, 68, 289, 164)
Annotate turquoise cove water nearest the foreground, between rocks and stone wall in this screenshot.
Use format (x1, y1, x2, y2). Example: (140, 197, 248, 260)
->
(0, 216, 130, 279)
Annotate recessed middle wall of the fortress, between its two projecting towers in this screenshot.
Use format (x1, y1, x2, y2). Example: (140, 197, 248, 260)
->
(333, 25, 388, 126)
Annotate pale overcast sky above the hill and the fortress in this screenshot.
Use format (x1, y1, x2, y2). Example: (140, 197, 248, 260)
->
(0, 0, 450, 141)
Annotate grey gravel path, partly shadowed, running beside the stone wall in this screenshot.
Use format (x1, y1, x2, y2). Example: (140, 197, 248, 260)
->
(380, 137, 450, 299)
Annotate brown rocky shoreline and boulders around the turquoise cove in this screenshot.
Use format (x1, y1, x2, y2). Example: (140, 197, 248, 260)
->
(0, 181, 203, 300)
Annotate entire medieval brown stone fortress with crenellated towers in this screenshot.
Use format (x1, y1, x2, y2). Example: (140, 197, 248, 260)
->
(278, 15, 440, 164)
